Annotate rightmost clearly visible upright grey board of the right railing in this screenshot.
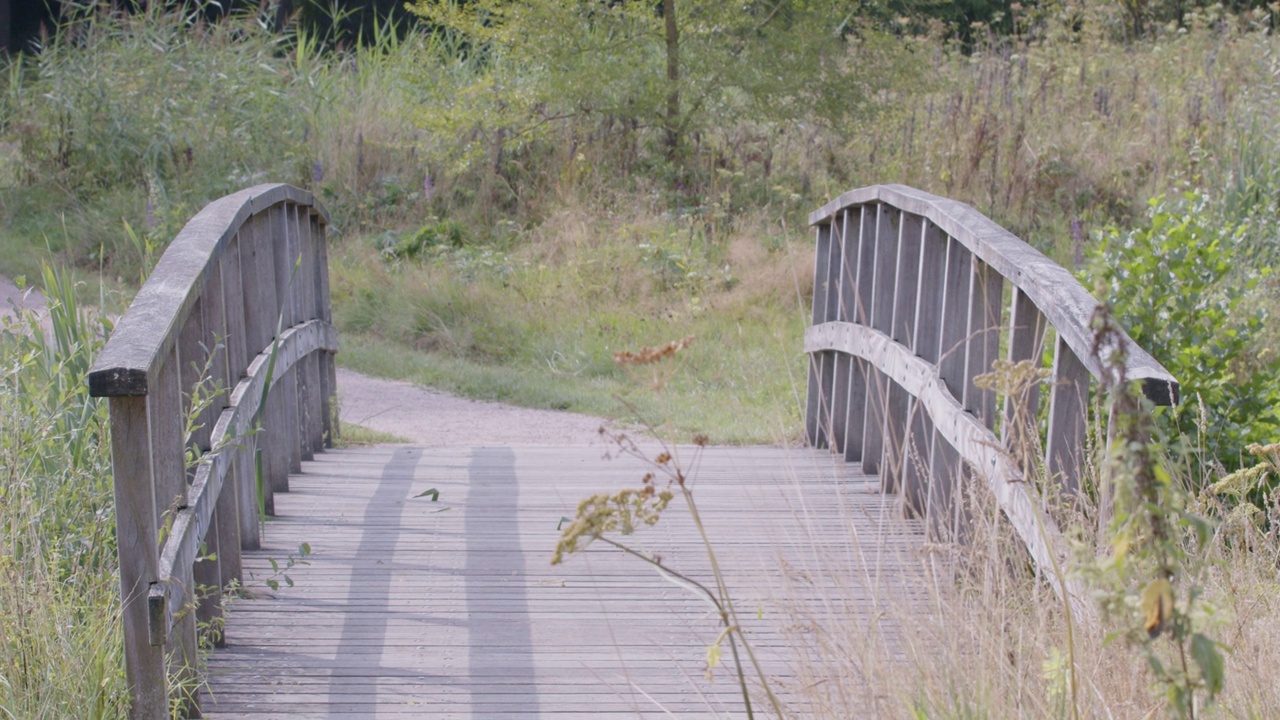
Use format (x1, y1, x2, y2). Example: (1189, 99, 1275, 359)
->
(1046, 336, 1089, 497)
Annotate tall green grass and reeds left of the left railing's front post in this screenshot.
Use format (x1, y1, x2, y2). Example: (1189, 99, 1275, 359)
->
(0, 268, 128, 720)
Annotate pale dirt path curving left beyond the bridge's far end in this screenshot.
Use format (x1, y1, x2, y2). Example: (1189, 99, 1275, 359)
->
(0, 275, 614, 446)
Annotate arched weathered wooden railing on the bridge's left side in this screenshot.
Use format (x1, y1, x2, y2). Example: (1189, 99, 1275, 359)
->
(88, 184, 337, 719)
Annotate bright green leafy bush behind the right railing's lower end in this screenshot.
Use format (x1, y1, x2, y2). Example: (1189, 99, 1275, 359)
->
(1092, 192, 1280, 484)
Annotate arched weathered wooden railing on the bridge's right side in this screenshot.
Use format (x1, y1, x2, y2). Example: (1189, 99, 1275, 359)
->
(805, 184, 1178, 604)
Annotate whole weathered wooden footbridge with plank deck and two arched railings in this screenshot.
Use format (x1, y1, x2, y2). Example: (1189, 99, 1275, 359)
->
(90, 184, 1178, 719)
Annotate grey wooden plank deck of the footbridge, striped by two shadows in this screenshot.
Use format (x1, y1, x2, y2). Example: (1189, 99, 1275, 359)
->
(204, 446, 923, 719)
